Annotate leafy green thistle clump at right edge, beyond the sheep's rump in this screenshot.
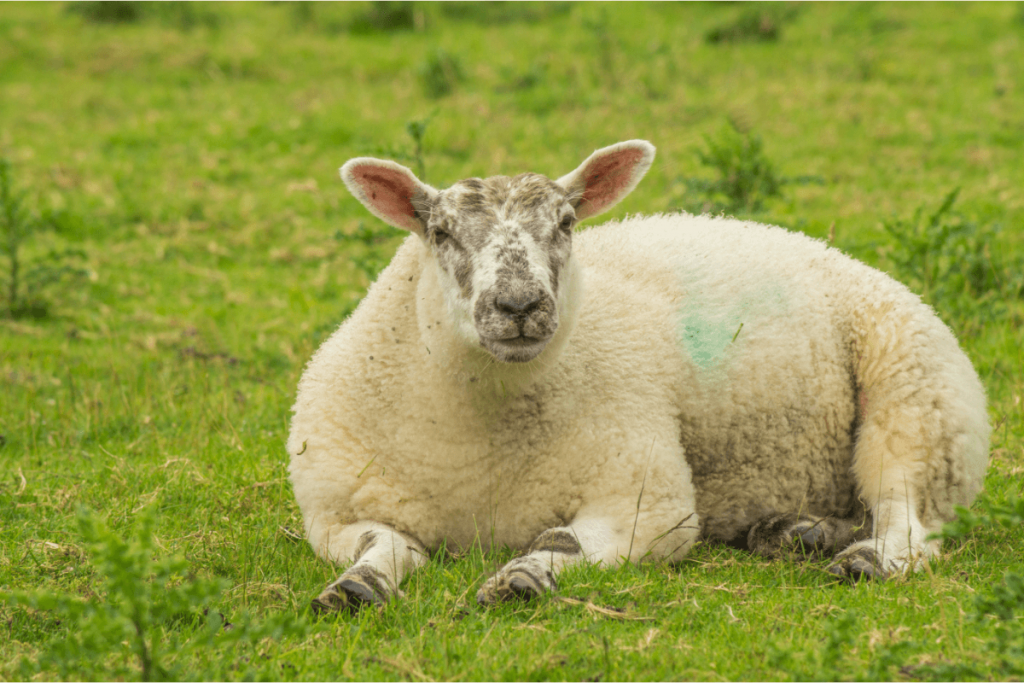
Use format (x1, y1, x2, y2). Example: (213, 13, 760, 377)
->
(881, 188, 1024, 334)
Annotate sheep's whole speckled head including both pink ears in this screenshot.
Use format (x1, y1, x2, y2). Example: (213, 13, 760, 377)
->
(341, 140, 654, 362)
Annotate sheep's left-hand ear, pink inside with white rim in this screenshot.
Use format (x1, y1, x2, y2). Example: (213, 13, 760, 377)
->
(341, 157, 437, 238)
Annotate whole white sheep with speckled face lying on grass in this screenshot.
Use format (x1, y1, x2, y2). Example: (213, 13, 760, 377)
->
(287, 140, 989, 611)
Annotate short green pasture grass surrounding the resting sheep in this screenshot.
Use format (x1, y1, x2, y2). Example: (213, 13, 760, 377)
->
(0, 3, 1024, 680)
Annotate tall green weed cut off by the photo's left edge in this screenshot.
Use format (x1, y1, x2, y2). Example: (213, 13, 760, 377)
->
(0, 159, 85, 317)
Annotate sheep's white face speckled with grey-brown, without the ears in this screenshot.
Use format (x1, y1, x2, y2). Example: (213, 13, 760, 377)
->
(424, 173, 575, 362)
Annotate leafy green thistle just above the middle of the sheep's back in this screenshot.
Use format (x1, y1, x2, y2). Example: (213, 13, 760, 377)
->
(686, 120, 783, 213)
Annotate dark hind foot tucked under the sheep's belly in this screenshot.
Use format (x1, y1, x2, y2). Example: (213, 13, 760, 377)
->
(746, 513, 862, 559)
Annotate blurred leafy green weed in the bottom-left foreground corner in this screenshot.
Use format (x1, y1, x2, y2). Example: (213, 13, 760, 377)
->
(0, 509, 308, 681)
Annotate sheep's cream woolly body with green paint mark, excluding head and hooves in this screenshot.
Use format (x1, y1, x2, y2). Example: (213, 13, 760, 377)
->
(288, 214, 989, 563)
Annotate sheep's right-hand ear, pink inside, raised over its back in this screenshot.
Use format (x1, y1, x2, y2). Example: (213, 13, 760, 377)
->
(558, 140, 654, 220)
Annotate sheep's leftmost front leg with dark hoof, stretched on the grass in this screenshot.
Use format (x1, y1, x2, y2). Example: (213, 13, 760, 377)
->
(312, 521, 426, 614)
